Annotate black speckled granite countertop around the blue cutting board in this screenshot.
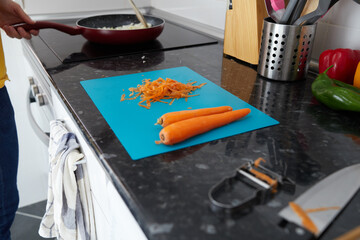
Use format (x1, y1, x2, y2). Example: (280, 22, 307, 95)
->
(26, 17, 360, 240)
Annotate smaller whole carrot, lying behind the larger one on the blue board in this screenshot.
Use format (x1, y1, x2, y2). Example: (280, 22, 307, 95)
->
(156, 106, 232, 127)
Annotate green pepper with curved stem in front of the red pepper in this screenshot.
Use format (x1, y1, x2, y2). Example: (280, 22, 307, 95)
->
(311, 66, 360, 112)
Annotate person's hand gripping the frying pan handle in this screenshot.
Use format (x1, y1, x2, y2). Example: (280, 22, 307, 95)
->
(0, 0, 39, 39)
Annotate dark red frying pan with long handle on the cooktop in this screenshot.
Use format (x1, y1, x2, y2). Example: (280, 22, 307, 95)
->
(15, 14, 165, 44)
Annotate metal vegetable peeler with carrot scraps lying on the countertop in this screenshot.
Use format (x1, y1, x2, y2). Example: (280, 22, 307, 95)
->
(208, 158, 295, 214)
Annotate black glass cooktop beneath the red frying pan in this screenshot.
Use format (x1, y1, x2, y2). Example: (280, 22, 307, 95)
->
(39, 17, 217, 63)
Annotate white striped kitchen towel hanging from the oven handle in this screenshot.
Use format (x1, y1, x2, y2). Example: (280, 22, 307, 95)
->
(39, 120, 96, 240)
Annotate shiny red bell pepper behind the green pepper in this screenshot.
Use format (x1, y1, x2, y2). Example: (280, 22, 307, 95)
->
(319, 48, 360, 84)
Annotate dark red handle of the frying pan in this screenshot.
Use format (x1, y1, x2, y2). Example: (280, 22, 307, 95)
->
(13, 21, 83, 35)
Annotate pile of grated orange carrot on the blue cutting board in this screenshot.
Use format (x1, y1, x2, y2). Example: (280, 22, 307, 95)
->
(120, 78, 206, 109)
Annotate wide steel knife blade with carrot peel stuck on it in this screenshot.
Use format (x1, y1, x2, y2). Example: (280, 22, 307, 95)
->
(279, 164, 360, 239)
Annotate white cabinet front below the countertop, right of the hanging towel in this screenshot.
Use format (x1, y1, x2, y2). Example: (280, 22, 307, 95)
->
(51, 90, 147, 240)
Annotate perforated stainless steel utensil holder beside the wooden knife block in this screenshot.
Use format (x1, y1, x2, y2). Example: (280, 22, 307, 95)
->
(257, 18, 316, 81)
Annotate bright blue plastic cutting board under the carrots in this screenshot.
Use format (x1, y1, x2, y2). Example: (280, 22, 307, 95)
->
(81, 67, 279, 160)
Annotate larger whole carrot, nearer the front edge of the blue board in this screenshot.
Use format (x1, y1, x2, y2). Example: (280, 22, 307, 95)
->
(156, 108, 250, 145)
